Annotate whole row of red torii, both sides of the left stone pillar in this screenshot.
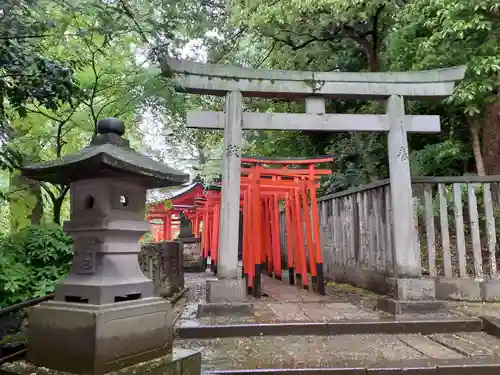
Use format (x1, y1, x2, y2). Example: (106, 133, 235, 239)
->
(148, 156, 332, 297)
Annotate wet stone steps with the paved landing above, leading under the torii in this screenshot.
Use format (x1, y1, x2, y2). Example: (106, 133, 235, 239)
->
(174, 274, 500, 375)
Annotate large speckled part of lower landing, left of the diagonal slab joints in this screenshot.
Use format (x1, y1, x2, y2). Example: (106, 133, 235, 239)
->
(175, 335, 426, 370)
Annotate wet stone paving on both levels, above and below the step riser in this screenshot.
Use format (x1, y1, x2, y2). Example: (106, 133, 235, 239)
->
(175, 273, 500, 375)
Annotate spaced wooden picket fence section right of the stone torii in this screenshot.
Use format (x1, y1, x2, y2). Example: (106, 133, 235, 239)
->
(412, 176, 500, 281)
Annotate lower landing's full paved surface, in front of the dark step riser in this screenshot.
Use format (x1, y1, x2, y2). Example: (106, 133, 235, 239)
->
(175, 332, 500, 371)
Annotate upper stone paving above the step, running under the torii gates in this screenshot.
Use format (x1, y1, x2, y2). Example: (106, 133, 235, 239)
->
(177, 272, 464, 326)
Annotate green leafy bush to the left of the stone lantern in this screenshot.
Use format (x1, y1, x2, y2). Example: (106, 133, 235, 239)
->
(0, 225, 73, 307)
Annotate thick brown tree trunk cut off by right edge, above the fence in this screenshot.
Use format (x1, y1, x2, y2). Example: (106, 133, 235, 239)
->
(481, 94, 500, 175)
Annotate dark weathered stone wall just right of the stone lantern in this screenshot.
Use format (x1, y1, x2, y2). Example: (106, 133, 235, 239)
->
(139, 241, 184, 297)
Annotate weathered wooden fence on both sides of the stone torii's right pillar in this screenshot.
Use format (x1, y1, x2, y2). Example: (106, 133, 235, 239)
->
(282, 176, 500, 300)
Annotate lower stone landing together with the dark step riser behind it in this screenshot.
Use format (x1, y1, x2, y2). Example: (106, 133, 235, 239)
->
(175, 310, 500, 375)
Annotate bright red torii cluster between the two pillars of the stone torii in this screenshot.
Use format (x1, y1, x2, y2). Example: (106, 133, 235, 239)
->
(241, 156, 333, 297)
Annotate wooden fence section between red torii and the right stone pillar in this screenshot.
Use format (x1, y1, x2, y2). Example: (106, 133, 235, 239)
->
(319, 180, 392, 274)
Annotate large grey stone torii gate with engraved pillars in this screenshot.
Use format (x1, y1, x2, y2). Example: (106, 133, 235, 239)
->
(161, 58, 465, 302)
